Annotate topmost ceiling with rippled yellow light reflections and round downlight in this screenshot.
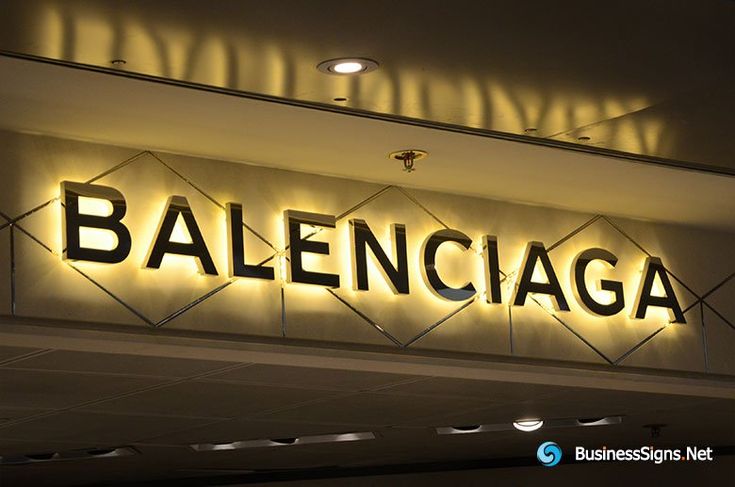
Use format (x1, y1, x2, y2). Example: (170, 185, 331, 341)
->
(0, 0, 735, 175)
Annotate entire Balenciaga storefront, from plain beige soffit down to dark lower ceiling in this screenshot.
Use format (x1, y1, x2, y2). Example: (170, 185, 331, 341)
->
(0, 1, 735, 485)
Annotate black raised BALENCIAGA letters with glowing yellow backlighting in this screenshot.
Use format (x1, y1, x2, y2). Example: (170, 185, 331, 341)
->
(61, 181, 686, 323)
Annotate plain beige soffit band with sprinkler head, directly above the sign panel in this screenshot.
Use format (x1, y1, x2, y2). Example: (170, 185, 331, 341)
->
(0, 57, 735, 231)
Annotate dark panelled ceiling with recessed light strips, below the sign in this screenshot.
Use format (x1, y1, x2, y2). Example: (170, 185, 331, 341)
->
(0, 344, 735, 485)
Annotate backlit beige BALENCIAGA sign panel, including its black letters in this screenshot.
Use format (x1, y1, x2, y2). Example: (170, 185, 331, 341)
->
(0, 131, 735, 374)
